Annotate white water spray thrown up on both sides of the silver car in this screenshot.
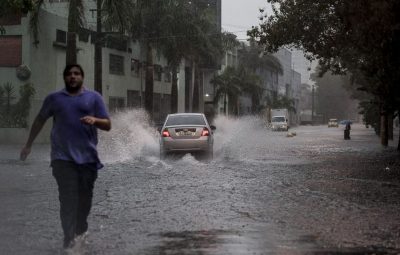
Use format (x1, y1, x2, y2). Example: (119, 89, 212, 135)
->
(99, 109, 276, 164)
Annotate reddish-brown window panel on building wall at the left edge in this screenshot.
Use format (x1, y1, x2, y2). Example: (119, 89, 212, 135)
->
(0, 36, 22, 67)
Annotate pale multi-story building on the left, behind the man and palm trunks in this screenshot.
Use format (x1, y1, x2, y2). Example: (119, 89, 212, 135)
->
(0, 0, 190, 142)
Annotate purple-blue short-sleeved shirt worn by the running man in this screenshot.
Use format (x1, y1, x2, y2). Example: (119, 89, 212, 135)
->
(39, 88, 109, 169)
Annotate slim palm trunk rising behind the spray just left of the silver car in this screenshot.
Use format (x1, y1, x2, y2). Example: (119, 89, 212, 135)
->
(144, 43, 154, 119)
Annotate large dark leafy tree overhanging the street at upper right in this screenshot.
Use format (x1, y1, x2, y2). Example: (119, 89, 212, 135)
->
(248, 0, 400, 149)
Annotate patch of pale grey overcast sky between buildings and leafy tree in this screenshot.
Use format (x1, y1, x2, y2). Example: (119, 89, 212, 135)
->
(222, 0, 269, 40)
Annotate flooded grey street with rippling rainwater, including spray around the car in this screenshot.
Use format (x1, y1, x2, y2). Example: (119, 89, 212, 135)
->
(0, 111, 400, 255)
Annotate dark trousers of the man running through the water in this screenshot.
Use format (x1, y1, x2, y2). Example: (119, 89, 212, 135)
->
(51, 160, 97, 247)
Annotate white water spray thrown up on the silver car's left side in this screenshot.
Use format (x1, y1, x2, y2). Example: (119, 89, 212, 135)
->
(99, 109, 159, 163)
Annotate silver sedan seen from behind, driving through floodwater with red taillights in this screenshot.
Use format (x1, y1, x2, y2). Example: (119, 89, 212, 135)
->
(159, 113, 216, 159)
